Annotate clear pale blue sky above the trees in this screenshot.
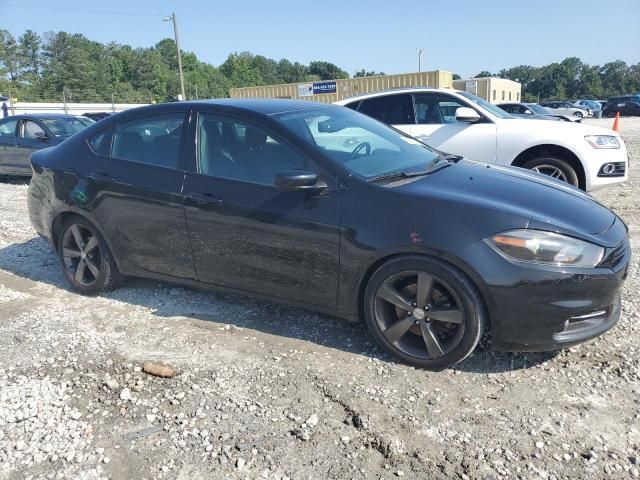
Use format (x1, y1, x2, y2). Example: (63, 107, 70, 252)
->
(0, 0, 640, 78)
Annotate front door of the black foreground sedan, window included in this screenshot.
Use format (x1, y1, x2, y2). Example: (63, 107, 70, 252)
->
(184, 111, 340, 309)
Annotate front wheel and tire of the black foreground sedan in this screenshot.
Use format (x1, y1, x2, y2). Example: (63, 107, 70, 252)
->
(364, 255, 487, 371)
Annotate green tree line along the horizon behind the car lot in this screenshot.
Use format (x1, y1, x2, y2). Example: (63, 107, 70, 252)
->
(0, 30, 640, 103)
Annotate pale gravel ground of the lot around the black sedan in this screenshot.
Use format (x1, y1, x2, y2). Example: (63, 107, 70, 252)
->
(0, 118, 640, 480)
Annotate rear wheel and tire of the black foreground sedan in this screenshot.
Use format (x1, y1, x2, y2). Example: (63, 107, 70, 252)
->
(57, 216, 124, 296)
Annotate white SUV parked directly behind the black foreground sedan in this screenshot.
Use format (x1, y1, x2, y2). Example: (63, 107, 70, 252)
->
(336, 87, 628, 191)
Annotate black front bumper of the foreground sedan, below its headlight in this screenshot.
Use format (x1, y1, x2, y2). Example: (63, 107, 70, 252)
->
(459, 225, 631, 351)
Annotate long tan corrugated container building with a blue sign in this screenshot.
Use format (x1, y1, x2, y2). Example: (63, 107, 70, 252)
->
(230, 70, 453, 103)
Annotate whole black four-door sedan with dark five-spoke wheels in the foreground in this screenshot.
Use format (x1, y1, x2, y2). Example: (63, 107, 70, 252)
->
(28, 100, 630, 369)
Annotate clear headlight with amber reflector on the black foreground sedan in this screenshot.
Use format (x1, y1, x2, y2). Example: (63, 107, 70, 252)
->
(486, 230, 604, 268)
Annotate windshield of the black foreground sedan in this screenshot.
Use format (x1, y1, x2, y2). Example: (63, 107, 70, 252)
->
(273, 107, 440, 179)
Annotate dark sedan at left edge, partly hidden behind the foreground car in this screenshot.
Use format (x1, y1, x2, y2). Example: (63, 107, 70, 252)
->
(0, 113, 94, 177)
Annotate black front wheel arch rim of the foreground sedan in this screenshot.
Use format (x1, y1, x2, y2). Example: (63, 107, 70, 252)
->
(356, 251, 495, 328)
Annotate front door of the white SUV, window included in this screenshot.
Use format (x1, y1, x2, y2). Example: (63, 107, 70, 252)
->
(408, 92, 496, 162)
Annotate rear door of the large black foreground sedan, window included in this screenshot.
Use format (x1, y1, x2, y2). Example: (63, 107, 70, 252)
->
(86, 107, 195, 279)
